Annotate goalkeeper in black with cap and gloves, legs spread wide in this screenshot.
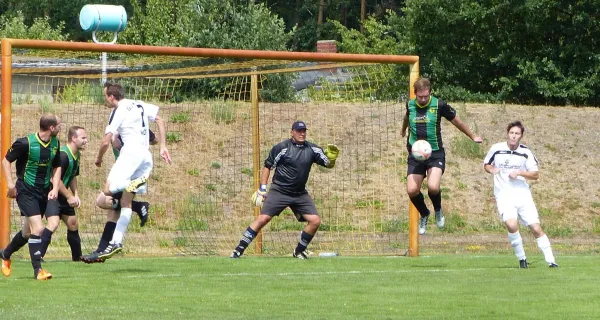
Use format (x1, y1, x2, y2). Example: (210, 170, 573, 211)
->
(231, 121, 339, 259)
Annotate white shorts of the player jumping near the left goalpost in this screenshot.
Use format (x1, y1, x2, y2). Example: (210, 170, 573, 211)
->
(107, 148, 153, 185)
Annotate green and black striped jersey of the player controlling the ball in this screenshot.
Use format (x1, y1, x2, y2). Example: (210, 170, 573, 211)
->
(406, 96, 456, 151)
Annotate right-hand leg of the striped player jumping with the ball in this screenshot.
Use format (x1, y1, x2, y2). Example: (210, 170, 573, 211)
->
(427, 150, 446, 228)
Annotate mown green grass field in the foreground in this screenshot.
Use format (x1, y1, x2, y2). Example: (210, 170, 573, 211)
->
(0, 255, 600, 320)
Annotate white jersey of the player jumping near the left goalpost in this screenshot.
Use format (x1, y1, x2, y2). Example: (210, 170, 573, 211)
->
(104, 99, 158, 151)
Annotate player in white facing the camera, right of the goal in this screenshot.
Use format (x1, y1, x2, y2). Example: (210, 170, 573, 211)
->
(483, 121, 558, 268)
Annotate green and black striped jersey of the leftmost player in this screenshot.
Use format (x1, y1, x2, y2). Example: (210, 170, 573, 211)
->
(6, 133, 60, 189)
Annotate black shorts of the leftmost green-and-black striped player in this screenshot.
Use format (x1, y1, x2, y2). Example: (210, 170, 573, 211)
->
(16, 180, 59, 218)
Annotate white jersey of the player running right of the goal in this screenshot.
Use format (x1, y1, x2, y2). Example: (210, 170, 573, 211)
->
(483, 142, 538, 199)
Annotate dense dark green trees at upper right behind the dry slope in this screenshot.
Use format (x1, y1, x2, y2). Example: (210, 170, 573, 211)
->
(397, 0, 600, 105)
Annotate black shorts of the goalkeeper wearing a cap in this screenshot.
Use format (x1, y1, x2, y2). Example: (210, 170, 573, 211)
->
(260, 189, 318, 222)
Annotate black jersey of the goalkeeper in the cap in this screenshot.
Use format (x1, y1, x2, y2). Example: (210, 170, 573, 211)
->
(265, 139, 329, 195)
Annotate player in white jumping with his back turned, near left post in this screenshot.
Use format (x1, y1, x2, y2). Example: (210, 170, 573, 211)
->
(91, 82, 171, 260)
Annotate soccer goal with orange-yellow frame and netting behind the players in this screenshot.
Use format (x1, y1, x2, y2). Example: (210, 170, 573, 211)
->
(0, 39, 419, 256)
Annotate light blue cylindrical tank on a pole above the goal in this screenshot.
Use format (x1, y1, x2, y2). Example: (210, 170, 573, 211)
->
(79, 4, 127, 32)
